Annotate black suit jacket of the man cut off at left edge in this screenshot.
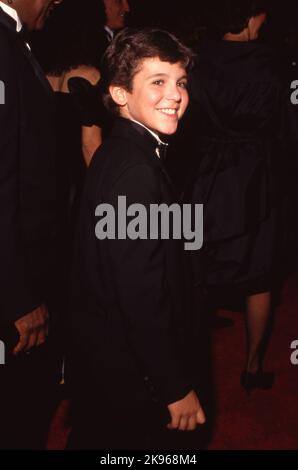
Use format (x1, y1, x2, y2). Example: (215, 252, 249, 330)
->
(0, 8, 56, 325)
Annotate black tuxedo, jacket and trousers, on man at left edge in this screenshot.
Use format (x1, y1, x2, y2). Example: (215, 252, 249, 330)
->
(0, 8, 60, 448)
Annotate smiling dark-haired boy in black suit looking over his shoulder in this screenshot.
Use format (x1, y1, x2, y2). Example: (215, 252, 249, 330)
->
(69, 29, 205, 449)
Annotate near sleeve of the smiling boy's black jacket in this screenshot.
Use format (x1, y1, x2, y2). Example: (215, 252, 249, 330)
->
(101, 164, 192, 404)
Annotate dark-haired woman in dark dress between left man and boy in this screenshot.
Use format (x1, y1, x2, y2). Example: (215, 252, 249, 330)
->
(32, 0, 105, 395)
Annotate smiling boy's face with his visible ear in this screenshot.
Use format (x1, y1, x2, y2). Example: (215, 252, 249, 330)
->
(110, 57, 188, 135)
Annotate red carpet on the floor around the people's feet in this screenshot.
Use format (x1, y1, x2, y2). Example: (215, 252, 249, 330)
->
(48, 274, 298, 450)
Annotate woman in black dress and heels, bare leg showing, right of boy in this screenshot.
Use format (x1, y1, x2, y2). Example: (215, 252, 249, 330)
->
(191, 0, 288, 393)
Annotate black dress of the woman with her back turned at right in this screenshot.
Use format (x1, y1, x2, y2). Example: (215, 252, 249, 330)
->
(187, 41, 286, 294)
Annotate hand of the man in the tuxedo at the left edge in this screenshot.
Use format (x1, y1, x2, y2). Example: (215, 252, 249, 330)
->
(13, 304, 49, 354)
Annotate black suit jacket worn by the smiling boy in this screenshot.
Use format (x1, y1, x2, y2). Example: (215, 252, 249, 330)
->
(70, 118, 192, 404)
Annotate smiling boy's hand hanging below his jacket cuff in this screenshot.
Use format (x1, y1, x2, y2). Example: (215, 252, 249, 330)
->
(167, 390, 206, 431)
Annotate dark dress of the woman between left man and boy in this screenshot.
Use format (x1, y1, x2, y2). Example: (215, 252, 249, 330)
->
(54, 81, 106, 374)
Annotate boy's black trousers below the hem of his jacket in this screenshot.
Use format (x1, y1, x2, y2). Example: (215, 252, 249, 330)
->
(67, 396, 202, 451)
